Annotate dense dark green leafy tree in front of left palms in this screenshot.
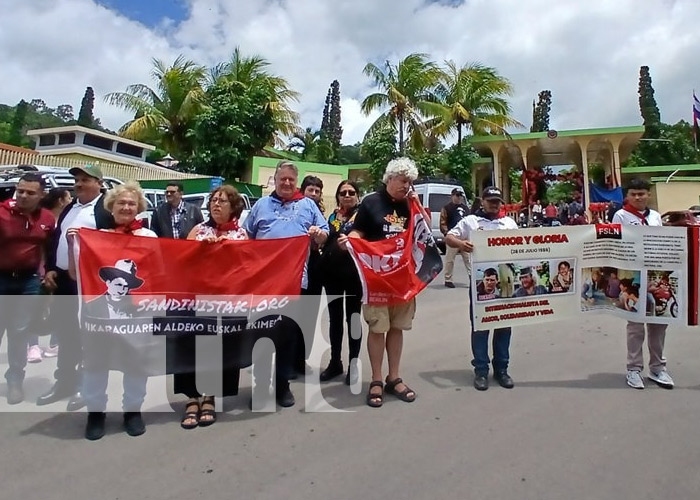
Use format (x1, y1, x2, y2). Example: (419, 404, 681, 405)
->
(189, 79, 275, 179)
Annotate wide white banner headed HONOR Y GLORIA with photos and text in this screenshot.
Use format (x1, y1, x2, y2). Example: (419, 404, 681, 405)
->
(471, 224, 688, 330)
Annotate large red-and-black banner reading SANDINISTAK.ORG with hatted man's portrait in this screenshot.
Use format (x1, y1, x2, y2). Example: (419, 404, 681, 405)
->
(78, 229, 309, 375)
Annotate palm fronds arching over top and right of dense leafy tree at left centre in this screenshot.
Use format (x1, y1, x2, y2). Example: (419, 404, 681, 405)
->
(209, 47, 302, 145)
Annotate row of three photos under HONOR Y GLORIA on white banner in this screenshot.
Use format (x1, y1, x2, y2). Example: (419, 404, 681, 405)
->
(475, 259, 576, 301)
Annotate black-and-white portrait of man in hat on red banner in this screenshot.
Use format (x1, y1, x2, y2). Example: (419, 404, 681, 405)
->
(85, 259, 143, 319)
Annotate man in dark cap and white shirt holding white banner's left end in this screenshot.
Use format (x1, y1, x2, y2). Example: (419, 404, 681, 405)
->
(445, 187, 518, 391)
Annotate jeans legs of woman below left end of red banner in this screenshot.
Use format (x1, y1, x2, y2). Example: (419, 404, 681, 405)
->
(82, 370, 148, 412)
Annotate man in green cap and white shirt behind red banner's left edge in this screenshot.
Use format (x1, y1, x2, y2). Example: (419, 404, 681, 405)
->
(36, 164, 114, 411)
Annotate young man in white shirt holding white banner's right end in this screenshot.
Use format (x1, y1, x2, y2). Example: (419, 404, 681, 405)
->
(612, 179, 673, 389)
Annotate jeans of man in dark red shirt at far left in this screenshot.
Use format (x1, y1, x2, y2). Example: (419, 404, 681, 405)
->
(0, 273, 39, 383)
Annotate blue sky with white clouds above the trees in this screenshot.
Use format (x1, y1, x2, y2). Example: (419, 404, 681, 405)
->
(0, 0, 700, 148)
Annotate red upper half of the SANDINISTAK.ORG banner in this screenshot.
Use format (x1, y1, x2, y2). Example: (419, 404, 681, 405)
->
(79, 229, 309, 296)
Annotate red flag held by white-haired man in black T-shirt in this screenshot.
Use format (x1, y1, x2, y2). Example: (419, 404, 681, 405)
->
(348, 201, 442, 306)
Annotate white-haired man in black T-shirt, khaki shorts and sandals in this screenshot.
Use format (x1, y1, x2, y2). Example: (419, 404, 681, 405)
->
(338, 158, 427, 408)
